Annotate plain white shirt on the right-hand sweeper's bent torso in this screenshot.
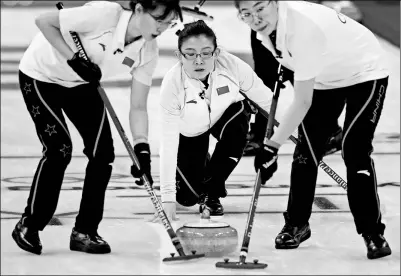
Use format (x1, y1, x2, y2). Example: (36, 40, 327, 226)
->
(257, 1, 389, 89)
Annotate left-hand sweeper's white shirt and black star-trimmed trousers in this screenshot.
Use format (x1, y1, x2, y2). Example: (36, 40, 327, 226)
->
(19, 1, 158, 253)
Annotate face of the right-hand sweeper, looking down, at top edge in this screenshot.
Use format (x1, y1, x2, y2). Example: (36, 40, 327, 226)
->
(239, 1, 278, 35)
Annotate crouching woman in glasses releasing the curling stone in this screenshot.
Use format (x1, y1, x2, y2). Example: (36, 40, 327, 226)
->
(156, 20, 272, 220)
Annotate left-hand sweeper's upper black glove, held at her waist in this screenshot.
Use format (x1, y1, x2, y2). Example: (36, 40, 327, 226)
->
(67, 52, 102, 82)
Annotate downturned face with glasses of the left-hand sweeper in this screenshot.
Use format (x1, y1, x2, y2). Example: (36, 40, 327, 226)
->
(128, 4, 176, 41)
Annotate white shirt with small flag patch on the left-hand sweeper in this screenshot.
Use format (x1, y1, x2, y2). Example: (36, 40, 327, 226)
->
(19, 1, 159, 87)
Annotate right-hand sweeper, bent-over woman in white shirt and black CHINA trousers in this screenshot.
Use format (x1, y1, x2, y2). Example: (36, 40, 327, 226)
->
(235, 0, 391, 259)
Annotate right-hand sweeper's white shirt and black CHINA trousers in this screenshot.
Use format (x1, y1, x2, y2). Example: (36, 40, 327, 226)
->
(258, 1, 389, 250)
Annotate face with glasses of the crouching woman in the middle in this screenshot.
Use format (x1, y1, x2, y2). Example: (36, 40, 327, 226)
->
(177, 35, 219, 80)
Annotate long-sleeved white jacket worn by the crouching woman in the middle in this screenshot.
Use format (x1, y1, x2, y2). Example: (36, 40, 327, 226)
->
(160, 50, 273, 202)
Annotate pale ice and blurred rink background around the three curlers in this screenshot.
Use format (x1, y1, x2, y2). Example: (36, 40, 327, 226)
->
(0, 0, 400, 275)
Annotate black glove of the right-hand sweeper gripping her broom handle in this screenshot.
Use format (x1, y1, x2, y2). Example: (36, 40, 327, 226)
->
(254, 141, 278, 185)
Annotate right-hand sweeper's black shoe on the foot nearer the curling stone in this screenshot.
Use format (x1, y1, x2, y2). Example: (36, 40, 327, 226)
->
(275, 212, 311, 249)
